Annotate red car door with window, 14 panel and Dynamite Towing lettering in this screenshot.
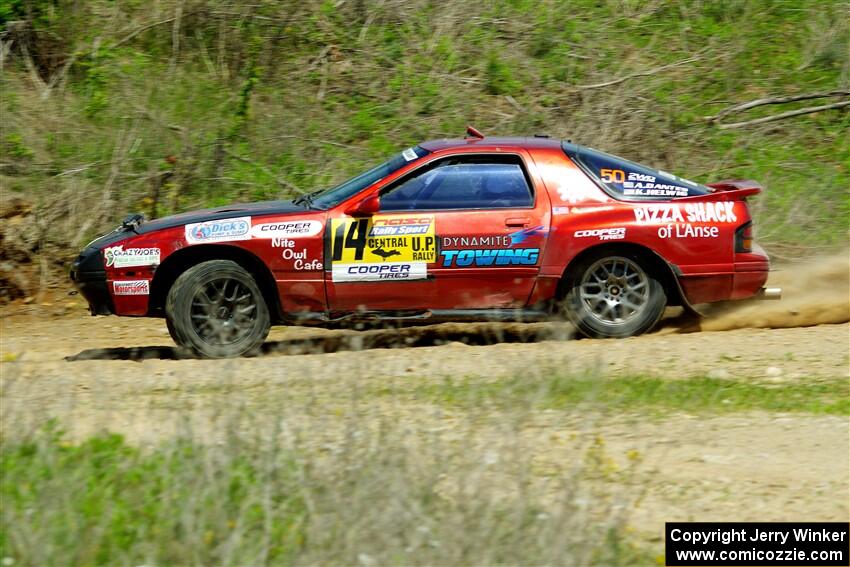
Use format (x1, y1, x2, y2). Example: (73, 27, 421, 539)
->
(326, 153, 550, 311)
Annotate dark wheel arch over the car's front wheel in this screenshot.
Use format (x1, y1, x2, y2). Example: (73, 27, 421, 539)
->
(148, 244, 283, 323)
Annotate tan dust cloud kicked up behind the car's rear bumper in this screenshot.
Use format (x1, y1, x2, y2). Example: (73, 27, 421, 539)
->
(700, 251, 850, 332)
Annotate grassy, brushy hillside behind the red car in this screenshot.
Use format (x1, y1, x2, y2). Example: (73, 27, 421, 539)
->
(0, 0, 850, 260)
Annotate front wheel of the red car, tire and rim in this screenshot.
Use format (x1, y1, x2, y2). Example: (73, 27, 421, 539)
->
(165, 260, 271, 358)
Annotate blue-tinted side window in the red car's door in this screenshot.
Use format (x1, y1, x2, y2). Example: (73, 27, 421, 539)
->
(381, 156, 533, 211)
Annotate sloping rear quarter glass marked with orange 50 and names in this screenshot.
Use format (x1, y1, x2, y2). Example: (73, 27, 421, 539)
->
(563, 142, 711, 200)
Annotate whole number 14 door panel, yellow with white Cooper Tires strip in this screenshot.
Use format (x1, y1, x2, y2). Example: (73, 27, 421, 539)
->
(331, 215, 437, 282)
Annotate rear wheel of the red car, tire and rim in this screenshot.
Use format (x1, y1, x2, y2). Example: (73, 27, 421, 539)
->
(563, 251, 667, 338)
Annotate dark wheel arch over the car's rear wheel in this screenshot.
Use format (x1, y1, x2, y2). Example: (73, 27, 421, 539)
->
(557, 242, 692, 309)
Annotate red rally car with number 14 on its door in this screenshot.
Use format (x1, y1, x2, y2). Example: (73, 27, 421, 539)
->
(71, 128, 779, 357)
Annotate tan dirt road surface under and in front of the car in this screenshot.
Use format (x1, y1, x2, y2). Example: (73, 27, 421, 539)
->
(0, 300, 850, 540)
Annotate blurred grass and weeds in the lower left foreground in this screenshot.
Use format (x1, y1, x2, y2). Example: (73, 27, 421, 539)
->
(0, 426, 649, 565)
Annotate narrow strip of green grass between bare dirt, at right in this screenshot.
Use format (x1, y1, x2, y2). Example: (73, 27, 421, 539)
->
(402, 375, 850, 415)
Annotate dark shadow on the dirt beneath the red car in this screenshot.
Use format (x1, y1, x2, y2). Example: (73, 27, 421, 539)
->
(65, 323, 575, 362)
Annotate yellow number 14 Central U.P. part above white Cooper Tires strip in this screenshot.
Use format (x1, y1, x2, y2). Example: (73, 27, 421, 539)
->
(331, 215, 437, 265)
